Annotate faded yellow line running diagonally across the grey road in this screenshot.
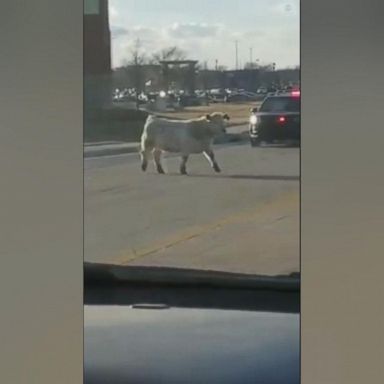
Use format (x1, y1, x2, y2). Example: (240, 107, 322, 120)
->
(112, 192, 299, 265)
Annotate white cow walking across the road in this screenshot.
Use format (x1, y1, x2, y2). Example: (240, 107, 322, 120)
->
(140, 112, 229, 174)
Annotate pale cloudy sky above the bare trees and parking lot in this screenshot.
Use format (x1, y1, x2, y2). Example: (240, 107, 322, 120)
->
(109, 0, 300, 69)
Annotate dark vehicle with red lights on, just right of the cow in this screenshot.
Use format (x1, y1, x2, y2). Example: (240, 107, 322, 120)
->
(249, 91, 301, 146)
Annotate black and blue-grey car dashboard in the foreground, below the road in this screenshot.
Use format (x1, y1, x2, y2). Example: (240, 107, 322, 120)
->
(84, 265, 300, 384)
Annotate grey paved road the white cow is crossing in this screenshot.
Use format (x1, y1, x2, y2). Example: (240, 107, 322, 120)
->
(84, 139, 300, 275)
